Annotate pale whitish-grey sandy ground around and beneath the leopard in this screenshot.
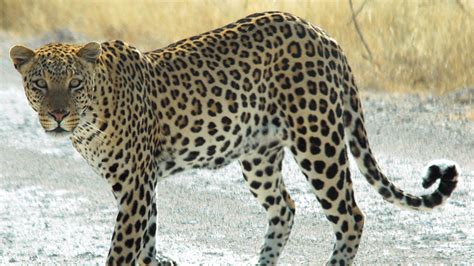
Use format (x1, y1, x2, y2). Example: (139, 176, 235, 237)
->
(0, 33, 474, 265)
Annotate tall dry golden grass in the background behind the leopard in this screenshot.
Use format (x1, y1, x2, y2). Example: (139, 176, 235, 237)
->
(0, 0, 474, 92)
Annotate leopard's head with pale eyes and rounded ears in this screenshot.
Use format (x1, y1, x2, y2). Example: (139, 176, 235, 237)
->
(10, 42, 101, 135)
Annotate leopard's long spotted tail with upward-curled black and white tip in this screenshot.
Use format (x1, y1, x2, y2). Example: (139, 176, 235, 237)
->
(341, 57, 460, 210)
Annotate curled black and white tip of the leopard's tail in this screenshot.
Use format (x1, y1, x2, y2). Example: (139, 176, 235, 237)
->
(422, 160, 459, 189)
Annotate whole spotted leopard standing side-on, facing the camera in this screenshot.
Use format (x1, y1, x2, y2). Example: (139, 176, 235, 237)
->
(10, 11, 460, 265)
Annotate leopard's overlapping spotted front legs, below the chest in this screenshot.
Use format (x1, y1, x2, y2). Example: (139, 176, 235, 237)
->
(107, 166, 176, 265)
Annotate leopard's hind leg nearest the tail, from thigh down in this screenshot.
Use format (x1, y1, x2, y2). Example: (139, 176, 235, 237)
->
(292, 138, 364, 265)
